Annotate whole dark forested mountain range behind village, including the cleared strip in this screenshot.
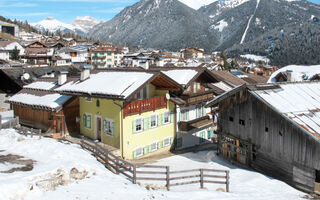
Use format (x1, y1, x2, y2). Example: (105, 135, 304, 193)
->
(89, 0, 320, 66)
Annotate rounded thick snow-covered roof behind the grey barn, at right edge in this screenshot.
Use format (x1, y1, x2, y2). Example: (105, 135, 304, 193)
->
(268, 65, 320, 83)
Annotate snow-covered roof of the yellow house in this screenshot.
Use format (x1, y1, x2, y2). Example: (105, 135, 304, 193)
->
(56, 72, 154, 98)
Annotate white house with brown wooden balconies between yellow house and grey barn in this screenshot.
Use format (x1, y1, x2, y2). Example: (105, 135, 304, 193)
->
(160, 67, 223, 150)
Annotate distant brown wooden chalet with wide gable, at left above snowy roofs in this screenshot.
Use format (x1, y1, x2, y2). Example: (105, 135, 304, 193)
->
(19, 42, 54, 66)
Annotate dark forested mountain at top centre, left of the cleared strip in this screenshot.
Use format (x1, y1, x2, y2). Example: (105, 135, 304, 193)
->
(89, 0, 216, 50)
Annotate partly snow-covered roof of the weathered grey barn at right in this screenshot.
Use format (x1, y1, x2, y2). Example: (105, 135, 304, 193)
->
(250, 82, 320, 140)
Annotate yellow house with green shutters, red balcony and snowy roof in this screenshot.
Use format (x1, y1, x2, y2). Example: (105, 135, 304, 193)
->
(59, 70, 181, 159)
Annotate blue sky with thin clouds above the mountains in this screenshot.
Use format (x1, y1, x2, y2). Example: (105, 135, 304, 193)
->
(0, 0, 320, 23)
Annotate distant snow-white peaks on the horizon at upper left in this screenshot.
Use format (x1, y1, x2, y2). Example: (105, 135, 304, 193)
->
(31, 16, 99, 35)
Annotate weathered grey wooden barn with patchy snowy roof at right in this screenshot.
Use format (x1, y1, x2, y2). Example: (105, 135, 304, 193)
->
(207, 82, 320, 193)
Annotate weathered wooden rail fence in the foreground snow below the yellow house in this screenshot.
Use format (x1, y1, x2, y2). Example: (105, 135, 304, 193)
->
(81, 139, 230, 192)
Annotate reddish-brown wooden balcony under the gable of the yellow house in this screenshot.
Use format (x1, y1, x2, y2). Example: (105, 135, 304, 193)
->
(123, 96, 167, 117)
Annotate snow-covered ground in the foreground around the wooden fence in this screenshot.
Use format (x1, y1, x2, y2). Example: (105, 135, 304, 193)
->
(0, 130, 305, 200)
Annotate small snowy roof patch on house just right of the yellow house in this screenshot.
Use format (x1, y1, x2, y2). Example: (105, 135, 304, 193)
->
(163, 69, 198, 85)
